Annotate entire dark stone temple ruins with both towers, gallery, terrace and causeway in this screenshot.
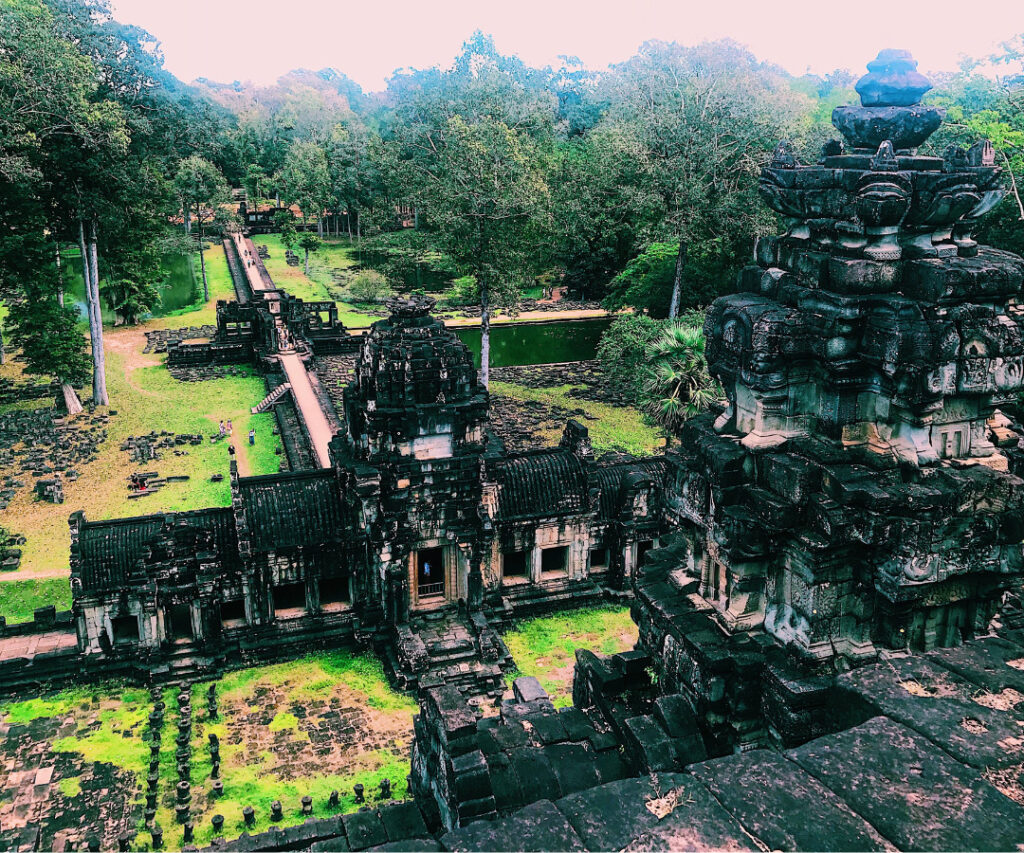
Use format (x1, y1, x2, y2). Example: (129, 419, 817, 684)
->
(0, 51, 1024, 850)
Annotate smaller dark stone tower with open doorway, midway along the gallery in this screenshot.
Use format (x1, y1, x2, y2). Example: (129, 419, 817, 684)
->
(331, 297, 487, 623)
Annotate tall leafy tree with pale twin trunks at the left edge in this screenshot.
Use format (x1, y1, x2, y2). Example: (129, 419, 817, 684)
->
(0, 0, 129, 404)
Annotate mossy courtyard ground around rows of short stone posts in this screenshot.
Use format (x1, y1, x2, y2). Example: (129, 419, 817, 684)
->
(0, 652, 416, 850)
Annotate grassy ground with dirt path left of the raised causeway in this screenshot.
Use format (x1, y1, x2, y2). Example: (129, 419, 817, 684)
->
(0, 245, 280, 622)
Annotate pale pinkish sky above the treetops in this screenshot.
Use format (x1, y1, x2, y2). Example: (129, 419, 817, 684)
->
(112, 0, 1024, 91)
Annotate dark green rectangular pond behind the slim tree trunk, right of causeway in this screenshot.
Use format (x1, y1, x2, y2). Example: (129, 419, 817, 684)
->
(455, 317, 611, 368)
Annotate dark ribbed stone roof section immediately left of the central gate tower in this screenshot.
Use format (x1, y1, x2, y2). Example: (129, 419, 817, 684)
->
(239, 469, 342, 551)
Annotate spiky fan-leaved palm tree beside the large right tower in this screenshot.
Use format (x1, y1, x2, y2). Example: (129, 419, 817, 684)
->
(641, 323, 722, 436)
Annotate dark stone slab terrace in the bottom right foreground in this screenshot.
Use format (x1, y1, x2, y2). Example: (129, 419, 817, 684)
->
(433, 632, 1024, 851)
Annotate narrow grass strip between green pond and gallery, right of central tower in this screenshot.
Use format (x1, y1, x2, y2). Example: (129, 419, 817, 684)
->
(489, 381, 665, 456)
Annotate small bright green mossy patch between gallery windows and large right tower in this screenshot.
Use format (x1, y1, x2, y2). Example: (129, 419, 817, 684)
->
(503, 606, 639, 708)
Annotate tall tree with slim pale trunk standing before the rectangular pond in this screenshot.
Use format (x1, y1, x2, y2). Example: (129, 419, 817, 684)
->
(384, 33, 554, 387)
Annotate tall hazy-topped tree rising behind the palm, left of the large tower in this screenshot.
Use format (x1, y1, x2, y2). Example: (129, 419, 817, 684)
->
(602, 41, 810, 317)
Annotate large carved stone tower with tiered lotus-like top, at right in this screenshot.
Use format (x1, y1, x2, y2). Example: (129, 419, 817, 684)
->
(655, 50, 1024, 667)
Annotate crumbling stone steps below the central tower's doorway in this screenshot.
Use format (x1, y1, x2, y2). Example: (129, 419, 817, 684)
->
(385, 609, 514, 702)
